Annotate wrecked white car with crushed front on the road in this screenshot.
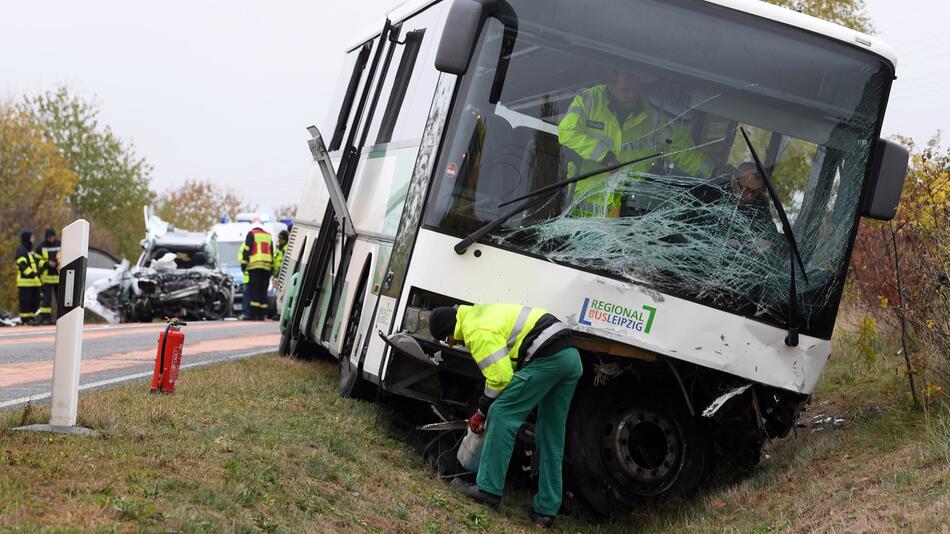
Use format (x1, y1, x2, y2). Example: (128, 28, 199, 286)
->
(85, 209, 234, 323)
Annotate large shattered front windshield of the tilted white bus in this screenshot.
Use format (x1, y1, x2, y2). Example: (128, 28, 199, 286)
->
(425, 0, 892, 337)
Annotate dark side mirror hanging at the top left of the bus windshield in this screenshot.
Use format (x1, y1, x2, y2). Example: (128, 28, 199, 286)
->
(435, 0, 495, 75)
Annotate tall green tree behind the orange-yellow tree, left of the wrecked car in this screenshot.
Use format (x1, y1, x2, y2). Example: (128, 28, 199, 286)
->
(21, 87, 155, 257)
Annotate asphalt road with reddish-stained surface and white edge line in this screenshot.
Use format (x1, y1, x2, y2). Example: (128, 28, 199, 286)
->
(0, 321, 280, 410)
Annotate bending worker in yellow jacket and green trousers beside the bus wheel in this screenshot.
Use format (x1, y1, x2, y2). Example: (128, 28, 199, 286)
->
(429, 304, 584, 528)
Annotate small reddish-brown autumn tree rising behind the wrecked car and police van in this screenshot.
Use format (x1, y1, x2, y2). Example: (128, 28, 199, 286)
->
(156, 180, 252, 231)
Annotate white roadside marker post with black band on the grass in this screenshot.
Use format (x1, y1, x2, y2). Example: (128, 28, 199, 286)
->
(16, 219, 95, 434)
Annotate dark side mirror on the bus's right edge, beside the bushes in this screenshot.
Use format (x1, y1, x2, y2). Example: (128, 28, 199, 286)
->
(861, 139, 910, 221)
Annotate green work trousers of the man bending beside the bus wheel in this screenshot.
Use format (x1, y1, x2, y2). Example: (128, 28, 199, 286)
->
(477, 348, 584, 515)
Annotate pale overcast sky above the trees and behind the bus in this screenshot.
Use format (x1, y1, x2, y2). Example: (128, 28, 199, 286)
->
(0, 0, 950, 216)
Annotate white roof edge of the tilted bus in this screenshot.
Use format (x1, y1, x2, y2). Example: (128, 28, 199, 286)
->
(347, 0, 897, 72)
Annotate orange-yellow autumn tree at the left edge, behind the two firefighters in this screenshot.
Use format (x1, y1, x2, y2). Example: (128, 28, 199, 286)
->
(0, 102, 79, 309)
